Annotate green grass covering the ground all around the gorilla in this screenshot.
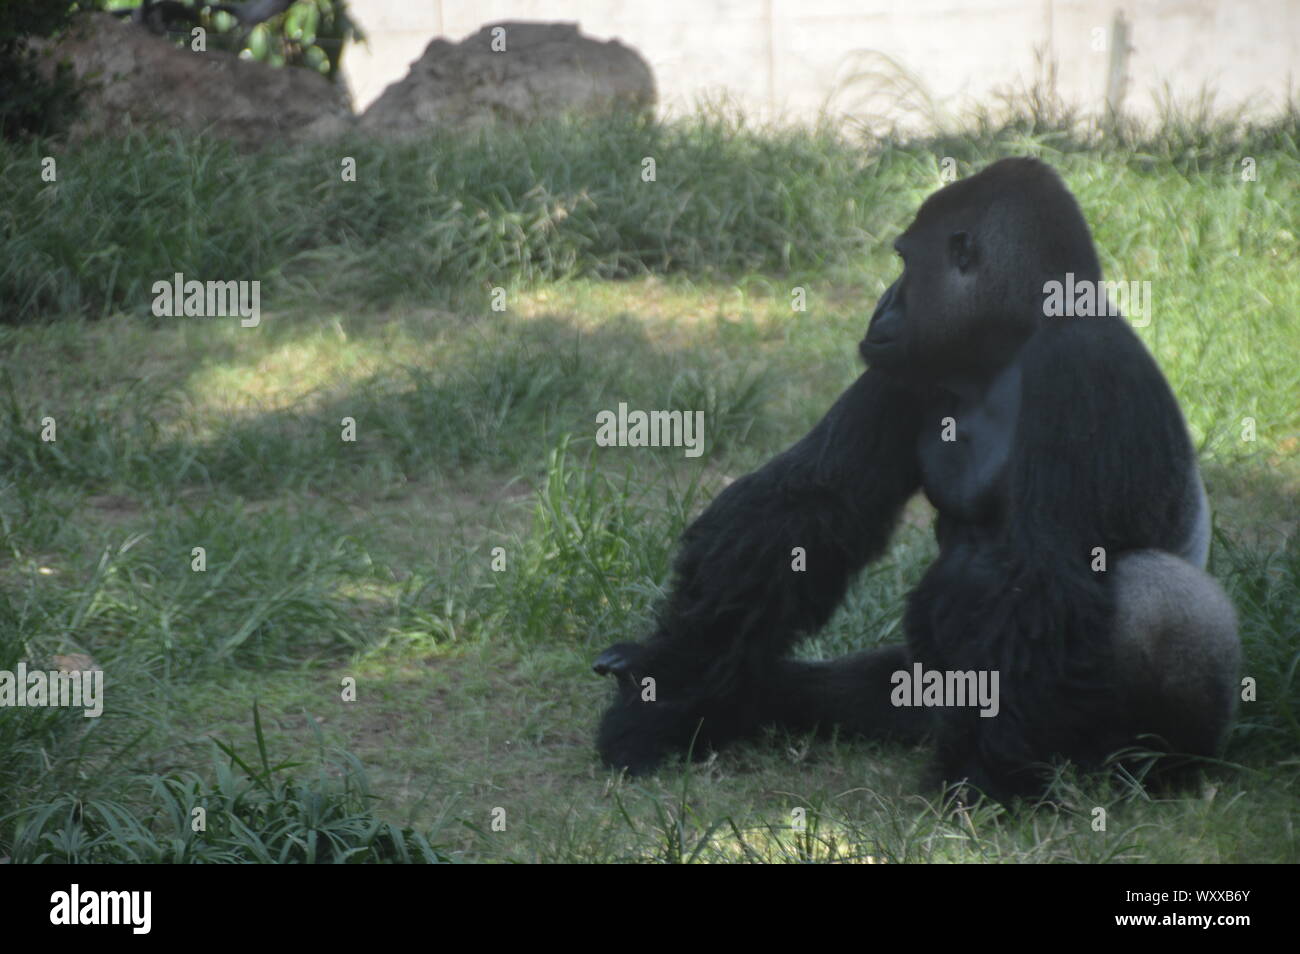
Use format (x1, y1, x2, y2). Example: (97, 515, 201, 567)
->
(0, 106, 1300, 863)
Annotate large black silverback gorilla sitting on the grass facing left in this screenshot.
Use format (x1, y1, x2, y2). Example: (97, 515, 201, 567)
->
(593, 159, 1240, 802)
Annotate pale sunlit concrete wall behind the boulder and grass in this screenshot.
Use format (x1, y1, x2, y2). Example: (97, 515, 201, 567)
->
(345, 0, 1300, 126)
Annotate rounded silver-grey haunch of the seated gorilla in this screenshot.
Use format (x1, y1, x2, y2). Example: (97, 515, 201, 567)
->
(1114, 550, 1242, 756)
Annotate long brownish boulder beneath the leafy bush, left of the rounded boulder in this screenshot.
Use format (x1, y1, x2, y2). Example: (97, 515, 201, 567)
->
(46, 13, 354, 148)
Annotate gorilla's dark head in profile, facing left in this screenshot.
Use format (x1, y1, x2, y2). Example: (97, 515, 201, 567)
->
(859, 159, 1101, 383)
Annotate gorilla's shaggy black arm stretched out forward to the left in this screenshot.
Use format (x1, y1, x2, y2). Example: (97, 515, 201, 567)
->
(593, 370, 924, 772)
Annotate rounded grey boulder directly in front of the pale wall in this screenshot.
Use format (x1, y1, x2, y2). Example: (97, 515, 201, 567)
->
(361, 21, 655, 136)
